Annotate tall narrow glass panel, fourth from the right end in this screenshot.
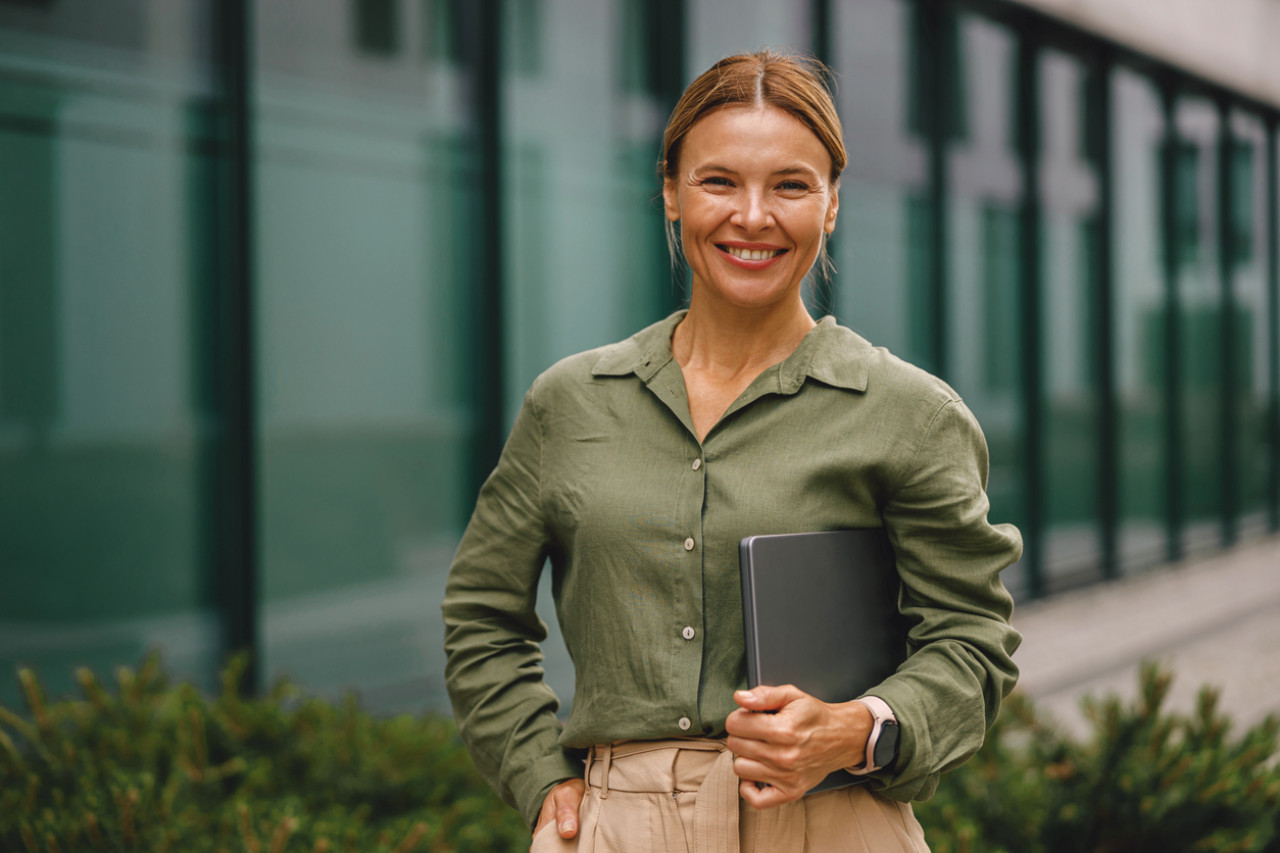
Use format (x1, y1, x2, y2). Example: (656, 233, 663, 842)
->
(1039, 51, 1101, 588)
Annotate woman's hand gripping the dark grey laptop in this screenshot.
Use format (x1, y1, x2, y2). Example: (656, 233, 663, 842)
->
(724, 685, 874, 808)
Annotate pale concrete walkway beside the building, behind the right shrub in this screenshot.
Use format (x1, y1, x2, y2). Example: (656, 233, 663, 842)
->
(1014, 537, 1280, 731)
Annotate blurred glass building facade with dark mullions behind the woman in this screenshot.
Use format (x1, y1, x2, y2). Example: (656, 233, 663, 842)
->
(0, 0, 1280, 710)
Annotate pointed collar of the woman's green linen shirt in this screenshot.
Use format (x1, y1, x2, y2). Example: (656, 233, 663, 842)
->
(591, 310, 872, 394)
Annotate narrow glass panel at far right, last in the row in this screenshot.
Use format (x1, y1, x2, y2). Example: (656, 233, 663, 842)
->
(1228, 113, 1272, 537)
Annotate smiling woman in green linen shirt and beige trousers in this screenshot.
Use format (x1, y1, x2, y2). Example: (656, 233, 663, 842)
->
(444, 51, 1021, 853)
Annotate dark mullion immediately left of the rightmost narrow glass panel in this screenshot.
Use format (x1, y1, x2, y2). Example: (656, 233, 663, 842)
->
(1217, 95, 1239, 546)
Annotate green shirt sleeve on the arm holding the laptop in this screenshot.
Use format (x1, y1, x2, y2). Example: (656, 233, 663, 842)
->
(868, 398, 1021, 800)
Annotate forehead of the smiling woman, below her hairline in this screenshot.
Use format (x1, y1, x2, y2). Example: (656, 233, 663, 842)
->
(680, 105, 831, 175)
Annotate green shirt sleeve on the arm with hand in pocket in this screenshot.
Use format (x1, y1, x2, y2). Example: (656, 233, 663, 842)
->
(443, 391, 581, 825)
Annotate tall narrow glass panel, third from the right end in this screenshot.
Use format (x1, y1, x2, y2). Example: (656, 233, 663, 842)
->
(1111, 68, 1169, 571)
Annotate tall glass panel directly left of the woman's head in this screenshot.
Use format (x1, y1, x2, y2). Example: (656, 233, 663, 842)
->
(503, 0, 678, 414)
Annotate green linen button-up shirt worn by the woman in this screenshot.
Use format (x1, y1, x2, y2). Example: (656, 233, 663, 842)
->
(443, 313, 1021, 824)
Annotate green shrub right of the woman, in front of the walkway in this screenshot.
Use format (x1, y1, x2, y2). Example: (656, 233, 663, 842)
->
(916, 666, 1280, 853)
